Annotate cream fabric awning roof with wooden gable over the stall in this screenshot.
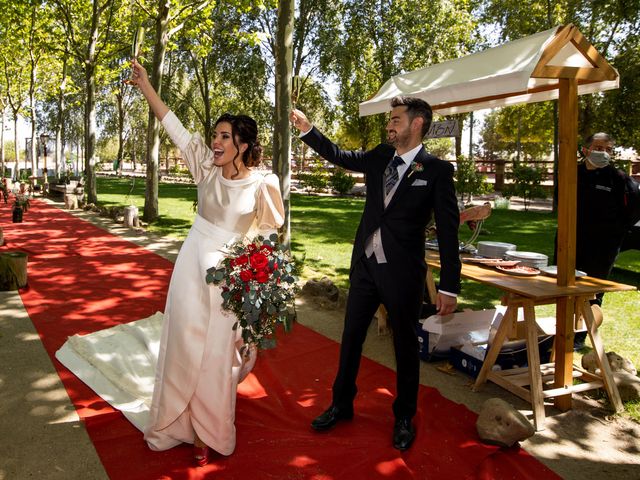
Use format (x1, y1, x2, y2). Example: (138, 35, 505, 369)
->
(360, 25, 619, 116)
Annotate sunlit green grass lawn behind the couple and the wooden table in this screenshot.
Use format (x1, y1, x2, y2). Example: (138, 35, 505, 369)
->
(98, 178, 640, 421)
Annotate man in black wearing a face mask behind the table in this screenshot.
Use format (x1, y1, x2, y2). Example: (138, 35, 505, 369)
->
(576, 133, 627, 310)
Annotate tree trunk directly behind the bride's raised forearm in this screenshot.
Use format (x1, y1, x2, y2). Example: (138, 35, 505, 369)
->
(143, 0, 170, 222)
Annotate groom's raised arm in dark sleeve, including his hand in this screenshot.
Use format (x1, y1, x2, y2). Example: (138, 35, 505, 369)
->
(289, 109, 368, 173)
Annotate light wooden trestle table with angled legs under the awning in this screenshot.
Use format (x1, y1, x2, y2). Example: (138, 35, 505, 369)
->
(425, 250, 636, 430)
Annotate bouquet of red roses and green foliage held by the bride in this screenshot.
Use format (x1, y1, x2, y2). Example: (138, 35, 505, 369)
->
(206, 234, 298, 348)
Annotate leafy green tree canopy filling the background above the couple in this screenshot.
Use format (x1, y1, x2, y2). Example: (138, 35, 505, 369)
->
(0, 0, 640, 214)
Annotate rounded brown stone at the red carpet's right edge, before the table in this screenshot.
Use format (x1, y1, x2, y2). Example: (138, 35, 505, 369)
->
(476, 398, 535, 447)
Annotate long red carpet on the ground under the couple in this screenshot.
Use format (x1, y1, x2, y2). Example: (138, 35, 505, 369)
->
(0, 201, 559, 480)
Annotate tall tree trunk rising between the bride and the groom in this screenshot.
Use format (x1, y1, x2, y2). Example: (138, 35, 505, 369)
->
(273, 0, 295, 249)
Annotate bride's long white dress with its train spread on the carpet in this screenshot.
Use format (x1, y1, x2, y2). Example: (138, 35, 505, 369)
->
(56, 112, 284, 455)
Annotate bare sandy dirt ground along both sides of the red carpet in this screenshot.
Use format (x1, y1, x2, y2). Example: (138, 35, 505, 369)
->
(0, 200, 640, 480)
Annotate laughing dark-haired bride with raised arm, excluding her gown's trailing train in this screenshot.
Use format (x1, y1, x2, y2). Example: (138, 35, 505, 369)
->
(131, 60, 284, 466)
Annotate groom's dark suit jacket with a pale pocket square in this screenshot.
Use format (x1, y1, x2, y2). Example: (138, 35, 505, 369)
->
(302, 127, 460, 293)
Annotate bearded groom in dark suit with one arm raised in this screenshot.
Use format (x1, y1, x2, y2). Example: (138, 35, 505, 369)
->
(290, 97, 460, 450)
